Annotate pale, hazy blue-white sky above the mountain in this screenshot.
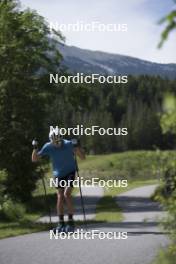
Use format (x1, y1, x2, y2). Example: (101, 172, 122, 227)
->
(21, 0, 176, 63)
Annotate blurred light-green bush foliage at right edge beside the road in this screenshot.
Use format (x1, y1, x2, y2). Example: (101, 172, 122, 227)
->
(156, 88, 176, 264)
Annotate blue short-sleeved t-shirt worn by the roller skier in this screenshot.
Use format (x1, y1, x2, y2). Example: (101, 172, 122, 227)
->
(38, 140, 76, 178)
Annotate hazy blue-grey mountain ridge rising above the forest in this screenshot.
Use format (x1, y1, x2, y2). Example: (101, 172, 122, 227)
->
(58, 44, 176, 79)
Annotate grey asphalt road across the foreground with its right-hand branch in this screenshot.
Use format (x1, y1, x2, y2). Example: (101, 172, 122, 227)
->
(0, 186, 168, 264)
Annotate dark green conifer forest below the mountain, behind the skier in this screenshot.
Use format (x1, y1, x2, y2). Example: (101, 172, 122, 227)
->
(45, 76, 176, 154)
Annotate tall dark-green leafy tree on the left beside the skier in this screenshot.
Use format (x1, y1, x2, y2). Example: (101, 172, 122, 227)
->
(0, 0, 61, 200)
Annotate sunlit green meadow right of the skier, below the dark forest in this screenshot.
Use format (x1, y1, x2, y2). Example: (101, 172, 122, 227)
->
(79, 151, 174, 180)
